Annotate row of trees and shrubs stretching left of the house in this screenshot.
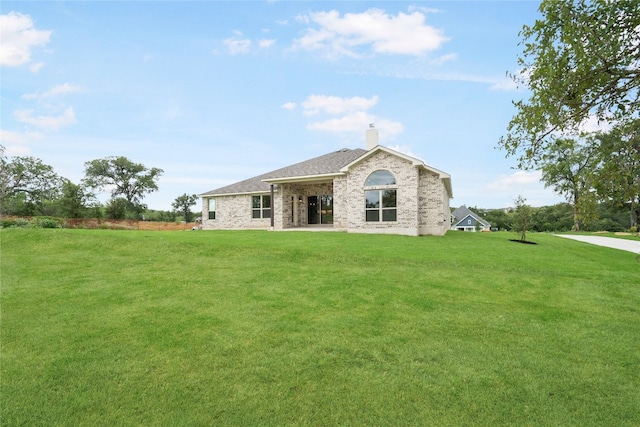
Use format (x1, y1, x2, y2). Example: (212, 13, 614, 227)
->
(0, 145, 197, 222)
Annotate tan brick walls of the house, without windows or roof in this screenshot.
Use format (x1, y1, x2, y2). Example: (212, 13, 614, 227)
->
(202, 151, 450, 235)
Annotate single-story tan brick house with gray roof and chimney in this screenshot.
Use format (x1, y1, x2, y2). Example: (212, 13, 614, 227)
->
(199, 125, 452, 236)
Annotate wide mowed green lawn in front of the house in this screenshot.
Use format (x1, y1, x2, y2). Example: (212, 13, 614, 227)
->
(0, 229, 640, 426)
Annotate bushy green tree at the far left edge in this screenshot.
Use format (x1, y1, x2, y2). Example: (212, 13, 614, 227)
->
(0, 147, 64, 215)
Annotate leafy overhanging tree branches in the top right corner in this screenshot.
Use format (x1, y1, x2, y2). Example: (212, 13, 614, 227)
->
(499, 0, 640, 167)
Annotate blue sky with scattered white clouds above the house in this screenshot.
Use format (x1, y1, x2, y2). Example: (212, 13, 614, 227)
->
(0, 1, 562, 210)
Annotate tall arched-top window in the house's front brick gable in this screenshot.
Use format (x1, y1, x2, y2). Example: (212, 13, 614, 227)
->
(364, 170, 397, 222)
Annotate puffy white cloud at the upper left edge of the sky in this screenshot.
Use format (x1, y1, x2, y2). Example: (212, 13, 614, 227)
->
(0, 12, 52, 67)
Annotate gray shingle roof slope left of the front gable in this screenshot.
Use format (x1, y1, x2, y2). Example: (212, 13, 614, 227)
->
(201, 148, 367, 196)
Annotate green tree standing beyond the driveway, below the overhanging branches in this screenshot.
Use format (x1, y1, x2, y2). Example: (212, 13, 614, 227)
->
(541, 139, 599, 231)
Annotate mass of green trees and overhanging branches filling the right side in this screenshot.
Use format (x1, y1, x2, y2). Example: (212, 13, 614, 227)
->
(498, 0, 640, 230)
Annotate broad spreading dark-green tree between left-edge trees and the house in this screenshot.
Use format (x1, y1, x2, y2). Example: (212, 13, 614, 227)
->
(83, 156, 163, 214)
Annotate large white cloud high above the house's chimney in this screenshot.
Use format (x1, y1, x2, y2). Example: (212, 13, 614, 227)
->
(294, 9, 448, 57)
